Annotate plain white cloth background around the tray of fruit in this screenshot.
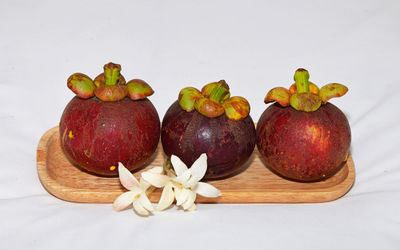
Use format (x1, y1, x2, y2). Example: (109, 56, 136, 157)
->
(0, 0, 400, 249)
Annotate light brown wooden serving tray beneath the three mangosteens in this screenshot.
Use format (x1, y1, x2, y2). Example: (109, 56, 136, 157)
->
(37, 127, 355, 203)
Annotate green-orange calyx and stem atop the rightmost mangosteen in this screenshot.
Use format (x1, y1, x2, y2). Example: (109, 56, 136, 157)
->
(264, 68, 348, 112)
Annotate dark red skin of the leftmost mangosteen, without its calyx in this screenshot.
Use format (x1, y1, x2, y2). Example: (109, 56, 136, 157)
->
(60, 97, 160, 176)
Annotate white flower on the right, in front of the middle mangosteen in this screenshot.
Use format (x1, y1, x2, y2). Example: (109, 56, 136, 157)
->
(142, 153, 221, 211)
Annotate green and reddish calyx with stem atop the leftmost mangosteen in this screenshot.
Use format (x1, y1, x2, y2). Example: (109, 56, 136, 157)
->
(67, 62, 154, 102)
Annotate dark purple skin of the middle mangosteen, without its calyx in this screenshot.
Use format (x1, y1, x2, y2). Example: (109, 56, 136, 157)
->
(161, 101, 256, 180)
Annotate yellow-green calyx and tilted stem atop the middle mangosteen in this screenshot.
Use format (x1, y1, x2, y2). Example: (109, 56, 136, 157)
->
(178, 80, 250, 120)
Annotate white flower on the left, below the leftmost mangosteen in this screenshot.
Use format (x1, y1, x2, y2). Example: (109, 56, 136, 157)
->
(113, 162, 163, 216)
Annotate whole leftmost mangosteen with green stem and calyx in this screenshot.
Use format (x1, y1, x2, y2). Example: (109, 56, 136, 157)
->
(60, 63, 160, 176)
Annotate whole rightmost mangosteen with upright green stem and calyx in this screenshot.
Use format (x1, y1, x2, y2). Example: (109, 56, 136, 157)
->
(257, 69, 351, 181)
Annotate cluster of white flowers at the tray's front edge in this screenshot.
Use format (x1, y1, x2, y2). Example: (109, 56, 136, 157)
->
(113, 154, 221, 216)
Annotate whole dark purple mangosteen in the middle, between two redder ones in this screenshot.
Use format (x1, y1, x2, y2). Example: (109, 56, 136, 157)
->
(161, 80, 256, 180)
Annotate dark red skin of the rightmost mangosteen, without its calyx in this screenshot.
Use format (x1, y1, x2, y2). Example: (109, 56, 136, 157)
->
(257, 103, 351, 181)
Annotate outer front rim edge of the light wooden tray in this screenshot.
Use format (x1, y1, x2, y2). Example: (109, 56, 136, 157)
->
(37, 126, 355, 203)
